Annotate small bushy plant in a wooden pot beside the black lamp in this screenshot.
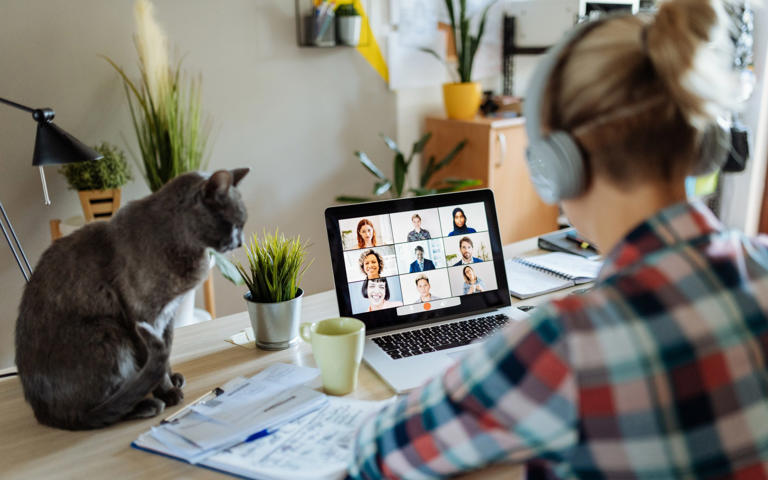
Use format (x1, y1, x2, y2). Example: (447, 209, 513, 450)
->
(59, 142, 132, 221)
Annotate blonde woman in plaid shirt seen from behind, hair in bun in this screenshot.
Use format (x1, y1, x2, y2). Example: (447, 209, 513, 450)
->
(350, 0, 768, 480)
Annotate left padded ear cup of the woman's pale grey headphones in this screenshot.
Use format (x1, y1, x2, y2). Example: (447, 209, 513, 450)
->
(527, 131, 586, 204)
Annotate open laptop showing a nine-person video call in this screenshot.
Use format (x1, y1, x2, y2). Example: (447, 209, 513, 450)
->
(325, 189, 527, 393)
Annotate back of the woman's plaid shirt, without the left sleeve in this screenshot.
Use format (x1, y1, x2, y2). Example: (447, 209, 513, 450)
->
(542, 204, 768, 479)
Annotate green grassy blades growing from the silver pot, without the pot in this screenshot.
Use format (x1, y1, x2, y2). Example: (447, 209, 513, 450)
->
(236, 230, 314, 303)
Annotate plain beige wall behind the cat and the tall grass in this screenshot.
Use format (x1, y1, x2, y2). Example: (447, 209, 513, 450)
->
(0, 0, 396, 369)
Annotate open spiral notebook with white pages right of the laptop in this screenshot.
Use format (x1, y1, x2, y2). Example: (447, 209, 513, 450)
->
(504, 252, 602, 299)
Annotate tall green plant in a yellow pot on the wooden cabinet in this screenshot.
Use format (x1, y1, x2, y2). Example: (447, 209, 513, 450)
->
(423, 0, 497, 120)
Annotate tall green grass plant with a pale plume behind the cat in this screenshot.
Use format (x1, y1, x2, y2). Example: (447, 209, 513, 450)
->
(104, 0, 209, 192)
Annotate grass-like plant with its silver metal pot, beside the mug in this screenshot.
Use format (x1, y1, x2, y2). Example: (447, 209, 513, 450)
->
(236, 230, 312, 350)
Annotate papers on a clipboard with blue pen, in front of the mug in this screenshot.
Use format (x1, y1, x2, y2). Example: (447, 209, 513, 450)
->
(132, 364, 390, 479)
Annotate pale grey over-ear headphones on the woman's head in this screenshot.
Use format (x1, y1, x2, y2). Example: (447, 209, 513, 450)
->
(523, 19, 731, 204)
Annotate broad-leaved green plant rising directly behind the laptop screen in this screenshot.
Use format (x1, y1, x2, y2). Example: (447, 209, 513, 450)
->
(336, 132, 481, 203)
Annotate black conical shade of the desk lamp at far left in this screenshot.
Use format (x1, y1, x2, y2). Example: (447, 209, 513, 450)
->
(32, 121, 103, 167)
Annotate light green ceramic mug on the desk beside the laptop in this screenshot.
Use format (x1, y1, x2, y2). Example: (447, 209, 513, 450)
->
(299, 317, 365, 395)
